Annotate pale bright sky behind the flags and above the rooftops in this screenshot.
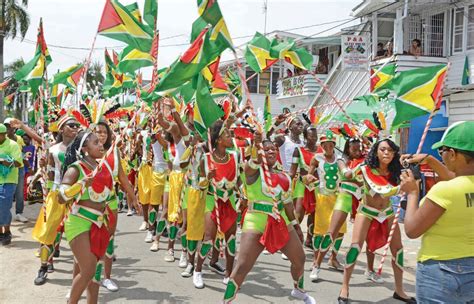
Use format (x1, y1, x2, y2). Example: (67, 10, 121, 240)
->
(4, 0, 361, 78)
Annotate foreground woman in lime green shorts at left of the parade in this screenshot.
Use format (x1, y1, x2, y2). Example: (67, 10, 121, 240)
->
(59, 130, 136, 303)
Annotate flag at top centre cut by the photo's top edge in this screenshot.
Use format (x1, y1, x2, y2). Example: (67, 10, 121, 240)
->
(191, 0, 234, 49)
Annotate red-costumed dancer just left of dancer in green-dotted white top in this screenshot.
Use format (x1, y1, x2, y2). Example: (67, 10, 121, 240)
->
(290, 125, 318, 246)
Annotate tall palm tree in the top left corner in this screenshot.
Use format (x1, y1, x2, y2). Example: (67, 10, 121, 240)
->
(0, 0, 30, 121)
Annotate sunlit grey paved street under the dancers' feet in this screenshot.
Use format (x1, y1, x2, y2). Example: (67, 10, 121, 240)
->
(0, 205, 419, 304)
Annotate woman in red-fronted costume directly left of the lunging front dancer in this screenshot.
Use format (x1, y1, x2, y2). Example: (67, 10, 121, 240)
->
(193, 120, 240, 288)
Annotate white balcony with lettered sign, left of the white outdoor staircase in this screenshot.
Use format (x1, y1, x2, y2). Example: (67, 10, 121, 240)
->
(277, 74, 328, 111)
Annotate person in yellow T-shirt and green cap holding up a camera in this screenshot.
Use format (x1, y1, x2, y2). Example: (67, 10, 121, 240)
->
(400, 121, 474, 303)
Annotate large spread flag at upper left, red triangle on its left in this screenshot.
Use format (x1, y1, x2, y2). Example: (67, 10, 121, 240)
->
(98, 0, 153, 52)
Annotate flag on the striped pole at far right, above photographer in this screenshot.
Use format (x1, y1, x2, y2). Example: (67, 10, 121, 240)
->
(392, 65, 447, 127)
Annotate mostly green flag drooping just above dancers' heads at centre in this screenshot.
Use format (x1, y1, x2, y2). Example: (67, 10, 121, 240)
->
(194, 74, 224, 138)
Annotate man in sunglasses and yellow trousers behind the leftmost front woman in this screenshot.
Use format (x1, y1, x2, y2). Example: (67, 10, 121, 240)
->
(32, 114, 80, 285)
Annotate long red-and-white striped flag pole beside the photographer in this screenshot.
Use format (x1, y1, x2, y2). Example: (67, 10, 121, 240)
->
(377, 63, 451, 275)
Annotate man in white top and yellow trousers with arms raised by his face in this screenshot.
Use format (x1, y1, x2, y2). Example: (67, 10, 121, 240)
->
(157, 99, 190, 268)
